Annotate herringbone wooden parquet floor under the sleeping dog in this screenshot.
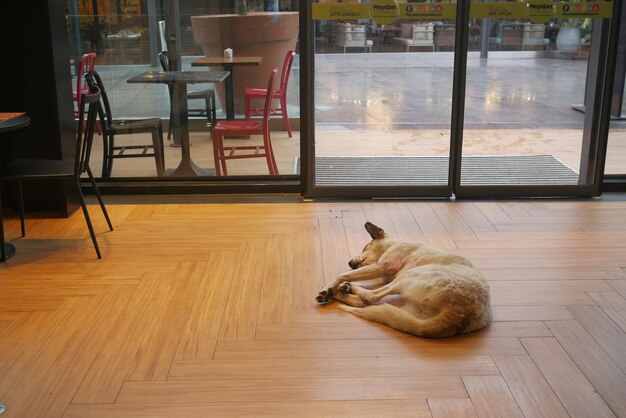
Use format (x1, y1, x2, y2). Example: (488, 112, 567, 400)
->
(0, 198, 626, 418)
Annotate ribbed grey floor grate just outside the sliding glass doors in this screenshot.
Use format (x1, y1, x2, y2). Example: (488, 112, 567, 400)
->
(294, 155, 578, 186)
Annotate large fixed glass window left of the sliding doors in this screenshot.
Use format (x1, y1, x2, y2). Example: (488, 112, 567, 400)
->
(67, 0, 300, 178)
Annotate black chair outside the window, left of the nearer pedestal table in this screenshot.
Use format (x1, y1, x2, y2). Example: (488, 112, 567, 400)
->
(85, 70, 165, 177)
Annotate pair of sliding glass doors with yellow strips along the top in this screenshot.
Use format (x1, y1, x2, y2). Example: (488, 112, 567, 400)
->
(302, 0, 613, 197)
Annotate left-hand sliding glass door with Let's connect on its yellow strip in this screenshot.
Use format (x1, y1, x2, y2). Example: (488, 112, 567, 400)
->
(304, 0, 456, 197)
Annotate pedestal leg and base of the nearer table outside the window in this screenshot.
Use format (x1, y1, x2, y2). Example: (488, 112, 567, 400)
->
(165, 83, 215, 176)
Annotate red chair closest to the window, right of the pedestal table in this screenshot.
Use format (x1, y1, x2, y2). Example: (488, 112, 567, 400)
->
(213, 68, 278, 176)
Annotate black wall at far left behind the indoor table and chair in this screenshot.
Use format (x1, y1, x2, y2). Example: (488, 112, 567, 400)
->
(0, 0, 77, 216)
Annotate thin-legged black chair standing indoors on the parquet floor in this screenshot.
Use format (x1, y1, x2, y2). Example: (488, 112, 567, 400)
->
(0, 88, 113, 258)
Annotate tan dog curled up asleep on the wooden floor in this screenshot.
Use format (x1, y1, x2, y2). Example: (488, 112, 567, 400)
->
(316, 222, 491, 338)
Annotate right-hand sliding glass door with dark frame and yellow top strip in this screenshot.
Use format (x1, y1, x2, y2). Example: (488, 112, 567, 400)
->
(455, 0, 612, 196)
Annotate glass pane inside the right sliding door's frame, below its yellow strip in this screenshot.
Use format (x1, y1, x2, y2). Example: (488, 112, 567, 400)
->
(461, 2, 592, 186)
